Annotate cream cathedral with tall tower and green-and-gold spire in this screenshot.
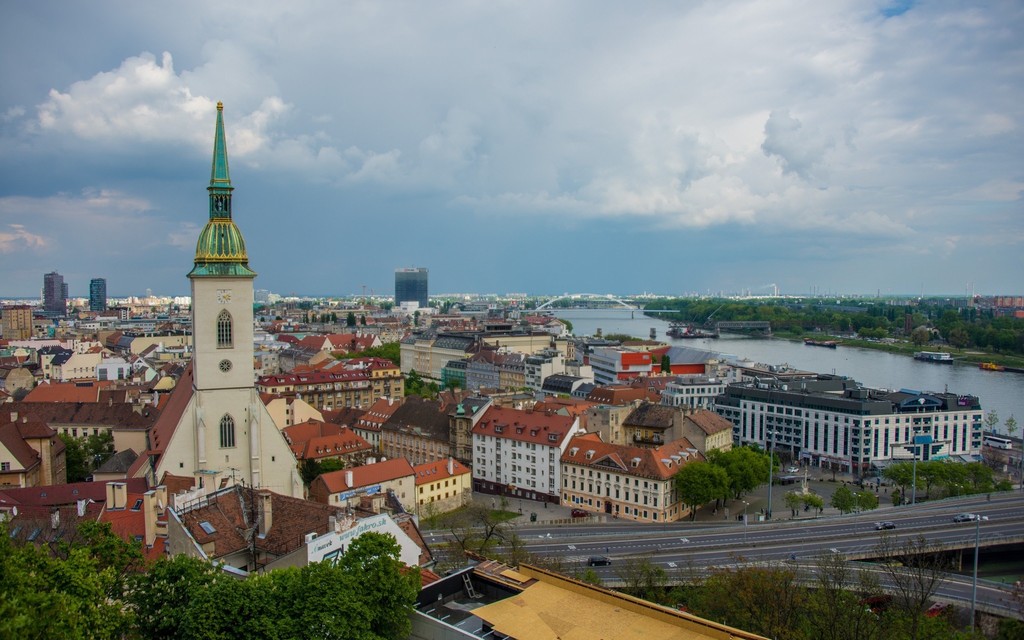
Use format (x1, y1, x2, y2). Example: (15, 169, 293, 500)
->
(132, 102, 302, 498)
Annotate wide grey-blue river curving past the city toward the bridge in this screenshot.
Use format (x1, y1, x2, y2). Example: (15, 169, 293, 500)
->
(555, 309, 1024, 436)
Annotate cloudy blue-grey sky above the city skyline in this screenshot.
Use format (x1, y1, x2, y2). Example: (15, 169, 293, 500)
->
(0, 0, 1024, 296)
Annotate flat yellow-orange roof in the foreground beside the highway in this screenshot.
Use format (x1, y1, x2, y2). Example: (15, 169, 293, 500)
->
(473, 566, 763, 640)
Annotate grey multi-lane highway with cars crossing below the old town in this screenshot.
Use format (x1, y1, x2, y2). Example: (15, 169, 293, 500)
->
(428, 493, 1024, 617)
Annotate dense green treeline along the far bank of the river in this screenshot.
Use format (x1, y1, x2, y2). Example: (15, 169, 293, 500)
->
(657, 298, 1024, 355)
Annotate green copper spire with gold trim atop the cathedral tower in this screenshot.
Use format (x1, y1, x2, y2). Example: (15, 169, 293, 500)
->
(188, 102, 256, 278)
